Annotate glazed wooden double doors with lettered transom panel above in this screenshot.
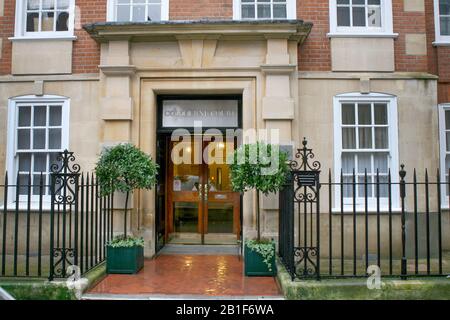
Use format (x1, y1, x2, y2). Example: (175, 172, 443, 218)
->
(156, 95, 242, 252)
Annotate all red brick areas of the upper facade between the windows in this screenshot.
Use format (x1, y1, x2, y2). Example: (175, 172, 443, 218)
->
(0, 0, 450, 84)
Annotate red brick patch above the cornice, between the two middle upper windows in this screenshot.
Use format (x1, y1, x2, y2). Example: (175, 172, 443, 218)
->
(169, 0, 233, 20)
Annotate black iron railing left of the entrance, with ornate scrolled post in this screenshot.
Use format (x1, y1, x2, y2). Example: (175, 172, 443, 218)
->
(0, 151, 114, 280)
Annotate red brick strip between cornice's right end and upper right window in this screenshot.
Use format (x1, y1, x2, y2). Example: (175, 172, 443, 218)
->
(297, 0, 331, 71)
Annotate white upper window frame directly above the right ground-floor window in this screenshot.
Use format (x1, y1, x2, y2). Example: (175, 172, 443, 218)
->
(328, 0, 398, 38)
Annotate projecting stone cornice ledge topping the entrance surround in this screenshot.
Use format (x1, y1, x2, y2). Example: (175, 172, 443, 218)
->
(83, 20, 312, 43)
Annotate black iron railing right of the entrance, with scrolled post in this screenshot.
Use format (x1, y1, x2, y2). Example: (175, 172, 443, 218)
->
(279, 141, 450, 279)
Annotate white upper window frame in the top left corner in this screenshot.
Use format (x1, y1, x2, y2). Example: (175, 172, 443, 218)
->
(12, 0, 75, 40)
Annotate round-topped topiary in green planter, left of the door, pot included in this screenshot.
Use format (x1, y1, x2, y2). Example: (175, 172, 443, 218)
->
(95, 143, 158, 273)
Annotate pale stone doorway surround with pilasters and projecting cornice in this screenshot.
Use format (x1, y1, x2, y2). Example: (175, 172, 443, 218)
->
(84, 20, 312, 257)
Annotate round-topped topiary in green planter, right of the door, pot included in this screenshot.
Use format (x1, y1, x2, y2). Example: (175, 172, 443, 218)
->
(230, 142, 289, 276)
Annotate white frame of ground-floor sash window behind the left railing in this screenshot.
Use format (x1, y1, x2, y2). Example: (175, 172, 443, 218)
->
(6, 95, 70, 209)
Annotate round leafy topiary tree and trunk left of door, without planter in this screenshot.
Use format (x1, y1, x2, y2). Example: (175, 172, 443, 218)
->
(95, 143, 159, 238)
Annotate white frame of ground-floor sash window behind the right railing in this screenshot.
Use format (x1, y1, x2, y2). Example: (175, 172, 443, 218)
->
(333, 93, 400, 212)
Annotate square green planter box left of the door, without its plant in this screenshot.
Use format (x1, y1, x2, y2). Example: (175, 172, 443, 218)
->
(106, 246, 144, 274)
